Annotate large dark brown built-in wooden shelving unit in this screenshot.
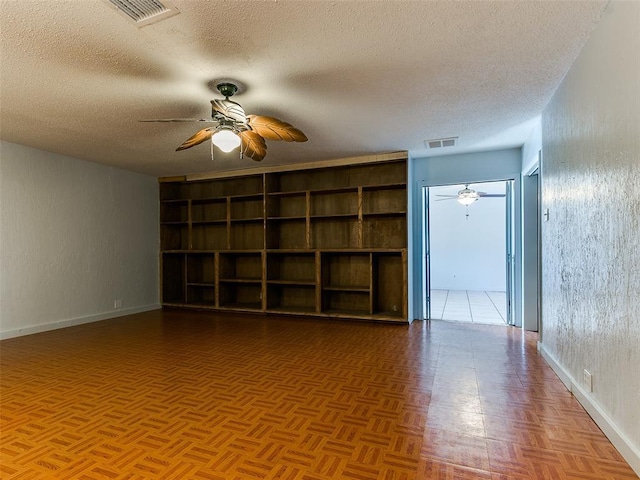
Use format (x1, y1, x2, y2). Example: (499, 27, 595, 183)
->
(160, 152, 407, 322)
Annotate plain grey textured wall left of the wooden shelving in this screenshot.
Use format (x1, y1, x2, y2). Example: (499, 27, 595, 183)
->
(0, 142, 158, 336)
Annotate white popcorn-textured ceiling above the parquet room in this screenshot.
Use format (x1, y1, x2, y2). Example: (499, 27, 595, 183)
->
(0, 0, 607, 176)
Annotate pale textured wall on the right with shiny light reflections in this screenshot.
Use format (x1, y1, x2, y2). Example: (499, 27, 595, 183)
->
(542, 1, 640, 467)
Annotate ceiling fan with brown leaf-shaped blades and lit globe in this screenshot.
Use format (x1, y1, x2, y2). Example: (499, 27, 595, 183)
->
(140, 82, 307, 162)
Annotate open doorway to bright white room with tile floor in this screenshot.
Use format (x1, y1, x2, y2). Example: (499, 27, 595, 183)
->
(423, 180, 515, 325)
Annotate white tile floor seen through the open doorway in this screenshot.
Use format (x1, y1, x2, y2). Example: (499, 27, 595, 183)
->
(431, 290, 507, 325)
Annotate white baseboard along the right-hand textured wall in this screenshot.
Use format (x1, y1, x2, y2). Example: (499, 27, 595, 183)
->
(538, 343, 640, 476)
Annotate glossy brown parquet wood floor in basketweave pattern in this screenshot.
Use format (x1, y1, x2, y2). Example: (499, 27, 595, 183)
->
(0, 311, 638, 480)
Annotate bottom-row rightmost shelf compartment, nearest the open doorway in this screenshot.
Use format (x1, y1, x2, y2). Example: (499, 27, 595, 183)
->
(371, 253, 406, 317)
